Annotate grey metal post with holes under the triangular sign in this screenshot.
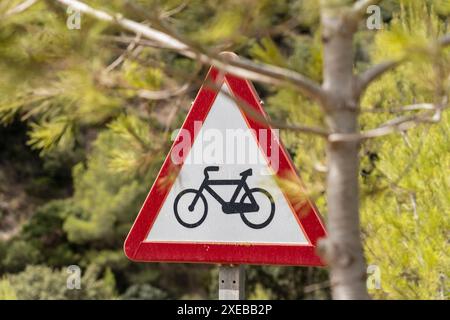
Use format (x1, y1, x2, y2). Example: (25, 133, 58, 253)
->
(219, 265, 245, 300)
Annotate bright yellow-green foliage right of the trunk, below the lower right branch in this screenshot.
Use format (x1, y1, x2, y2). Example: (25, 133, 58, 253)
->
(362, 113, 450, 299)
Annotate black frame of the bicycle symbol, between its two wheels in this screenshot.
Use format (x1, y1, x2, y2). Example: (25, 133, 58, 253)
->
(189, 176, 259, 213)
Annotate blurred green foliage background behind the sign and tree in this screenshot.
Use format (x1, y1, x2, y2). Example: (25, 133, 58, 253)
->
(0, 0, 450, 299)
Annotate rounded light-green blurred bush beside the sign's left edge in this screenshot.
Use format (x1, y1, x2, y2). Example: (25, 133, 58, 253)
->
(64, 116, 160, 243)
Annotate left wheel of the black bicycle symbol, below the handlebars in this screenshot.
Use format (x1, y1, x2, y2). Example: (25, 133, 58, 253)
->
(173, 189, 208, 228)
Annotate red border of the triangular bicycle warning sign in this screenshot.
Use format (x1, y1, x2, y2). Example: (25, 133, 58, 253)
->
(124, 67, 326, 266)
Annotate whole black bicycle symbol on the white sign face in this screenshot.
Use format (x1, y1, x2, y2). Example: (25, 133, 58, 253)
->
(173, 166, 275, 229)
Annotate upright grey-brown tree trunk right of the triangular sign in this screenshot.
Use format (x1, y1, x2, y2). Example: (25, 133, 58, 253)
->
(321, 10, 369, 299)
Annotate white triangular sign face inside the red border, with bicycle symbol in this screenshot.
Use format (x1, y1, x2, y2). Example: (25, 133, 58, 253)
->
(144, 84, 309, 245)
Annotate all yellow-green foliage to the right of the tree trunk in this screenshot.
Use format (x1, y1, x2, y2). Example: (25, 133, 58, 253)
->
(361, 1, 450, 299)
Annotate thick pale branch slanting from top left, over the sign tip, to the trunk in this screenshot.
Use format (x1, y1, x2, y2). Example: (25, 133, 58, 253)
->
(55, 0, 325, 102)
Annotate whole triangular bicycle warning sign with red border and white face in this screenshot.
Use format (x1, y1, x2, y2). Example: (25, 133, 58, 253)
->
(124, 62, 325, 266)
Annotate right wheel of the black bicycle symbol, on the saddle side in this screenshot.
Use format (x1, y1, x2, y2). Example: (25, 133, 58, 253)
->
(241, 188, 275, 229)
